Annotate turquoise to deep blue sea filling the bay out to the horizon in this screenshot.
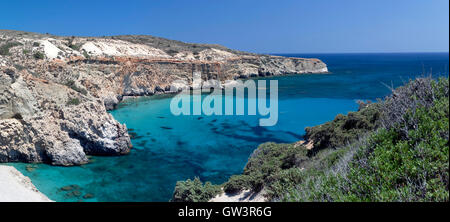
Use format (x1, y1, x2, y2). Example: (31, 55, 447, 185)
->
(6, 53, 449, 201)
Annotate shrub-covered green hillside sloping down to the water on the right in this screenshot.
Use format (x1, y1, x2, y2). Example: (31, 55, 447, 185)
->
(174, 78, 449, 201)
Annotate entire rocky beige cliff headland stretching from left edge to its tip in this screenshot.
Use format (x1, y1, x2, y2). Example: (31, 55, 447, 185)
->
(0, 30, 328, 166)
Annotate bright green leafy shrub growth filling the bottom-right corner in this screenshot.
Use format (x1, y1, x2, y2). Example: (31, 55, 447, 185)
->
(348, 94, 449, 201)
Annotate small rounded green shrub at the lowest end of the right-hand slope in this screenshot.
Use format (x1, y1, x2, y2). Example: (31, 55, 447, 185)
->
(171, 177, 221, 202)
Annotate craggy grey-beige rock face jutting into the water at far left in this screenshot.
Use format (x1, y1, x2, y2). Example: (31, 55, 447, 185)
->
(0, 65, 131, 166)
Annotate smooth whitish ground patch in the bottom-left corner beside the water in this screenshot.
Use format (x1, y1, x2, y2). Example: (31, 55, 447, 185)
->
(0, 165, 51, 202)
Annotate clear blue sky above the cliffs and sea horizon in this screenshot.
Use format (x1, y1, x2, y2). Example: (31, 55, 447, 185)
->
(0, 0, 449, 53)
